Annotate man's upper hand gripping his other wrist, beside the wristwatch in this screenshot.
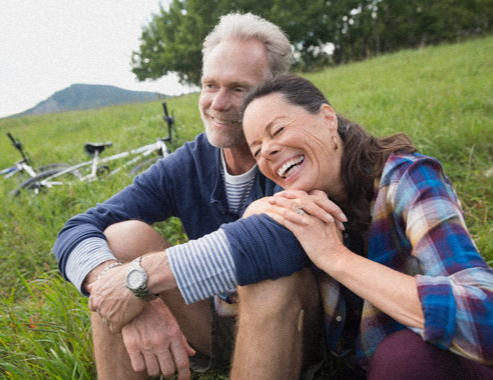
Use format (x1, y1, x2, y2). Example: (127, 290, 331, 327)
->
(88, 264, 144, 333)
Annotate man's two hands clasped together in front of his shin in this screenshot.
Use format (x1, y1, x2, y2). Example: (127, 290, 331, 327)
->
(88, 264, 195, 380)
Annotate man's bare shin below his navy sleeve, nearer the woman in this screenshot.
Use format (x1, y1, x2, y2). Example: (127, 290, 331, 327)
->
(231, 269, 323, 380)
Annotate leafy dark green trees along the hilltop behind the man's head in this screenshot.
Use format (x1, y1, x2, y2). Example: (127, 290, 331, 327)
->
(132, 0, 493, 84)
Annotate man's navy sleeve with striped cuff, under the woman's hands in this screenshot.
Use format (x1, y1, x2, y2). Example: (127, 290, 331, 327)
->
(167, 215, 310, 304)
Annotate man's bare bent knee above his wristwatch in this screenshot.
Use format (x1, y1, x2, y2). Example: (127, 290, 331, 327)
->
(104, 220, 171, 262)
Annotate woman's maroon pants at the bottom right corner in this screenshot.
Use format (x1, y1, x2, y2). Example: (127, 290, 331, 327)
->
(366, 329, 493, 380)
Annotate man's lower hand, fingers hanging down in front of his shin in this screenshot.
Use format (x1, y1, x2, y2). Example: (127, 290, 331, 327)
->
(122, 299, 195, 380)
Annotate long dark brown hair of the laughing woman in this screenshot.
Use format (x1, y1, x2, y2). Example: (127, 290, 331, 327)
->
(243, 75, 416, 232)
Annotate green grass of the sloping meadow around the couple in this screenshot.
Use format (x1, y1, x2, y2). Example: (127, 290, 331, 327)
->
(0, 37, 493, 380)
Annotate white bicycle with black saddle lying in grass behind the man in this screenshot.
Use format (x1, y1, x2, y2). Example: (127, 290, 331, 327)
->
(12, 102, 175, 196)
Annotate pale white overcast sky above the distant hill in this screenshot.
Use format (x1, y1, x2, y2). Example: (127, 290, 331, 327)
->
(0, 0, 196, 117)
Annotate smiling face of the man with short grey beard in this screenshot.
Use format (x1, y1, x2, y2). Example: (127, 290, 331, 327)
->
(199, 40, 268, 149)
